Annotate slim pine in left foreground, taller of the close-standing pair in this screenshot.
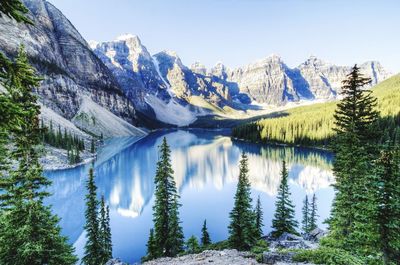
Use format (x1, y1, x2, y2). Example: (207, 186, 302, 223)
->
(82, 168, 102, 265)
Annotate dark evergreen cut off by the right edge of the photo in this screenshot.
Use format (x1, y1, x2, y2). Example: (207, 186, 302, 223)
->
(373, 146, 400, 265)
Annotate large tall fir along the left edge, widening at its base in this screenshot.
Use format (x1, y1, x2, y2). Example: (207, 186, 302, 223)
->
(0, 46, 77, 265)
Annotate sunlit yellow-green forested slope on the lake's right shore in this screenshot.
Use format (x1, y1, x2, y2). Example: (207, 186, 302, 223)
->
(234, 75, 400, 144)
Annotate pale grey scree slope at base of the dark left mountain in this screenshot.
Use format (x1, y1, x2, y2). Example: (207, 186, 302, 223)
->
(72, 96, 146, 138)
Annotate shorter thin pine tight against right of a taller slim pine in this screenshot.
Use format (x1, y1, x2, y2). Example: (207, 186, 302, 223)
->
(99, 196, 112, 264)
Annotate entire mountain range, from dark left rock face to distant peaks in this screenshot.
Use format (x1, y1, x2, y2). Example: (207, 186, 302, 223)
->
(0, 0, 391, 132)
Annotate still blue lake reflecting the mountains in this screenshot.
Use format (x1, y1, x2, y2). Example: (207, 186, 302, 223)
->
(45, 129, 334, 263)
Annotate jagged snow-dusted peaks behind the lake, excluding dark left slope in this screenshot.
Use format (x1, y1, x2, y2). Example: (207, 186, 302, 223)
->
(92, 34, 391, 126)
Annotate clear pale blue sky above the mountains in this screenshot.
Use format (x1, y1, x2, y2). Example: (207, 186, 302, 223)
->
(49, 0, 400, 73)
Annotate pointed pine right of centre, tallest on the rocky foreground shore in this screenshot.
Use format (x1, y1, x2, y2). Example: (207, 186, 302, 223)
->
(228, 153, 257, 250)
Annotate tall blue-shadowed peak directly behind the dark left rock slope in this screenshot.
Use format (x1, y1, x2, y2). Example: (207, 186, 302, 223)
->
(92, 35, 233, 126)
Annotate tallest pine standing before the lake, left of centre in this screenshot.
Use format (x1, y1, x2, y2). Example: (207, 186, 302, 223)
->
(153, 138, 184, 257)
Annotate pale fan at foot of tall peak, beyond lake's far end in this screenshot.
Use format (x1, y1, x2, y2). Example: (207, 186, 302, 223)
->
(145, 94, 197, 126)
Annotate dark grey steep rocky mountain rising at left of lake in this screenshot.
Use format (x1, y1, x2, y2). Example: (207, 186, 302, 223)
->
(0, 0, 143, 136)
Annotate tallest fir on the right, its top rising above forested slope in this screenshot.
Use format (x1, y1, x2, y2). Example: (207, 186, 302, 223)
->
(327, 65, 379, 255)
